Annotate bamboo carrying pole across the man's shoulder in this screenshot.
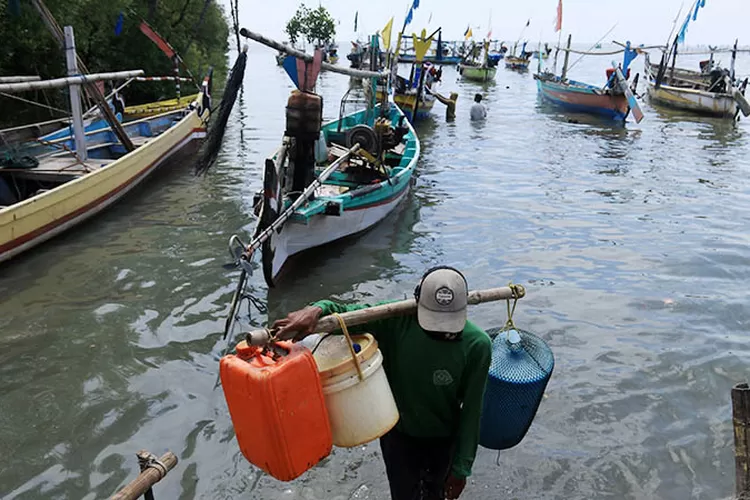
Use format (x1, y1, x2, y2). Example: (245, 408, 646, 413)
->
(247, 285, 526, 345)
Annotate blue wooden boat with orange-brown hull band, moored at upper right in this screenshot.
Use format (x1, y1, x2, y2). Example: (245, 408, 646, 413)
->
(534, 36, 643, 123)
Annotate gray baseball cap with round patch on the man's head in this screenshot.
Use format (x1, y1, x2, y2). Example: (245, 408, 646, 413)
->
(417, 269, 469, 333)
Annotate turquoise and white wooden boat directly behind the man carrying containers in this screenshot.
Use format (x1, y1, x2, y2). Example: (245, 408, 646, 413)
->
(255, 102, 420, 286)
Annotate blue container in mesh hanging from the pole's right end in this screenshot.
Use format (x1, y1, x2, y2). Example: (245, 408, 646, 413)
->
(479, 330, 555, 450)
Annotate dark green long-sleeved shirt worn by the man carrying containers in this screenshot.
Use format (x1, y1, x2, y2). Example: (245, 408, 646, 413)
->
(312, 300, 492, 477)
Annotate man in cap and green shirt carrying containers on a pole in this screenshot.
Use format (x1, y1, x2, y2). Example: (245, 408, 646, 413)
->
(273, 266, 491, 500)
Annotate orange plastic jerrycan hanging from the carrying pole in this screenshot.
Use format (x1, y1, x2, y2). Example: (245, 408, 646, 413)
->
(220, 341, 333, 481)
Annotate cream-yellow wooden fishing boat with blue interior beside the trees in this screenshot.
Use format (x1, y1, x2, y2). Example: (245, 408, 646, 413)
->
(0, 79, 211, 261)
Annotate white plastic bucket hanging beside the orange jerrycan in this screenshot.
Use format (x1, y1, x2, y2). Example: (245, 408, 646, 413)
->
(312, 335, 399, 448)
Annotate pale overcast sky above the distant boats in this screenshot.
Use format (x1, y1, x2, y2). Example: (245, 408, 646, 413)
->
(234, 0, 750, 45)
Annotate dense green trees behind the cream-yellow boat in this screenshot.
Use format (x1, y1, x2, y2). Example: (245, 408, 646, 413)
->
(0, 0, 229, 122)
